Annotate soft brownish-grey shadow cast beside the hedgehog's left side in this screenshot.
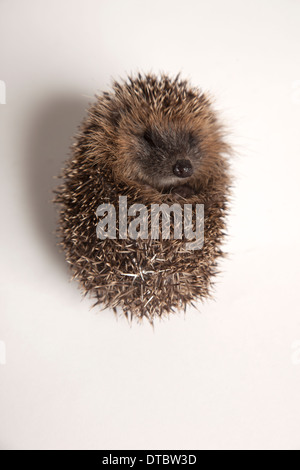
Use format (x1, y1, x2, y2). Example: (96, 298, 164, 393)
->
(26, 94, 91, 272)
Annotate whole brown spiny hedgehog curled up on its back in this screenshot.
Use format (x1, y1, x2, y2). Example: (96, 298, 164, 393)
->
(56, 74, 231, 322)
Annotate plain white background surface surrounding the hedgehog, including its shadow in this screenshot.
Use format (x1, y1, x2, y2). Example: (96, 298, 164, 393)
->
(0, 0, 300, 450)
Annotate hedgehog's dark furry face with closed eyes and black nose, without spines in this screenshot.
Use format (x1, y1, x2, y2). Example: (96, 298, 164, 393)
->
(132, 126, 202, 190)
